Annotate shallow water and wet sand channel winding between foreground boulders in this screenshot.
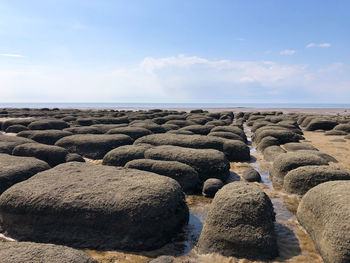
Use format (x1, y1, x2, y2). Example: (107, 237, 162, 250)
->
(85, 128, 323, 263)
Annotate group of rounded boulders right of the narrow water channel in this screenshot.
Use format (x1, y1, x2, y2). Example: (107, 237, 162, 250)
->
(247, 111, 350, 263)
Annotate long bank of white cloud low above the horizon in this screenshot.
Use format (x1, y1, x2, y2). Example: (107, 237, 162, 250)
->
(0, 55, 350, 102)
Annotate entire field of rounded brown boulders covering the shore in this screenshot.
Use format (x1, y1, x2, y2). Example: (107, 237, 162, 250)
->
(0, 108, 350, 262)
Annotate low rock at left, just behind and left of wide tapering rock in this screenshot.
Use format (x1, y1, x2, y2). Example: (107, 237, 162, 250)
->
(17, 130, 72, 145)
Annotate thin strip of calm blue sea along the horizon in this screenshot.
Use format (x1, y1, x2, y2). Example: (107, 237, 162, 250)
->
(0, 102, 350, 109)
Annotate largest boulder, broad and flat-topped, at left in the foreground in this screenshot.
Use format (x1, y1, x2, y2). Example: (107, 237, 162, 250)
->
(0, 162, 188, 250)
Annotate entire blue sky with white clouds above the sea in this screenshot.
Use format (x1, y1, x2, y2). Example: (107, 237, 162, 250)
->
(0, 0, 350, 103)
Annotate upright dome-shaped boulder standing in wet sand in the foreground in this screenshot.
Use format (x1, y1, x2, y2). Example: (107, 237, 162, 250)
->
(198, 182, 278, 259)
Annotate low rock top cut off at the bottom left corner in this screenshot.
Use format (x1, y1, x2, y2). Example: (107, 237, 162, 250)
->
(0, 242, 97, 263)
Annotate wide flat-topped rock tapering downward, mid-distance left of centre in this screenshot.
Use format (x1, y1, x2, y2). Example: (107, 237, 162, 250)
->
(55, 134, 133, 159)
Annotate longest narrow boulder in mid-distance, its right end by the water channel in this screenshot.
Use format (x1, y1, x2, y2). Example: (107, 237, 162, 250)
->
(135, 133, 250, 161)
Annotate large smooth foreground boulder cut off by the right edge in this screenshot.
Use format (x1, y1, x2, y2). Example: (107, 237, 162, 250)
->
(297, 181, 350, 263)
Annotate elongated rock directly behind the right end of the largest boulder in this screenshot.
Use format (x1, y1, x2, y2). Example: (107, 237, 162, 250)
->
(125, 159, 199, 193)
